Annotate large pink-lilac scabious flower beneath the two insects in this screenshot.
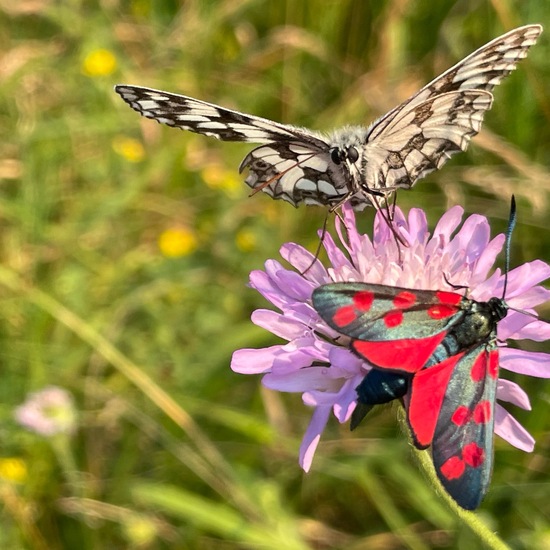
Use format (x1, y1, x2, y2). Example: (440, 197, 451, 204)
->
(231, 205, 550, 471)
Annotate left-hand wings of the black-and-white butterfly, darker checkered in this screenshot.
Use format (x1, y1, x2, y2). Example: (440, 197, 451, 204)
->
(115, 85, 352, 206)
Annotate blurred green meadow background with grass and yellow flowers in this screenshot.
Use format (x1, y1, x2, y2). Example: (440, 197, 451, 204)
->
(0, 0, 550, 550)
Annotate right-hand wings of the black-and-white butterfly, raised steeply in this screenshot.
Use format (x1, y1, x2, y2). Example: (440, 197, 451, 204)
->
(365, 25, 542, 201)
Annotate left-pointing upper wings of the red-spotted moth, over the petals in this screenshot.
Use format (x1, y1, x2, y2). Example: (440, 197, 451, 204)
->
(312, 283, 463, 373)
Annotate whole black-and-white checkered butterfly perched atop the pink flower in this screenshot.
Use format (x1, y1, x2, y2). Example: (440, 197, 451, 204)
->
(115, 25, 542, 210)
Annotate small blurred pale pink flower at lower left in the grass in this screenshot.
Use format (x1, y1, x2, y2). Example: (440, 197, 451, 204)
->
(15, 386, 76, 437)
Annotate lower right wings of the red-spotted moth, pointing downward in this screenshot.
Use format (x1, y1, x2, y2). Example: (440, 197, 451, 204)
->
(407, 348, 499, 510)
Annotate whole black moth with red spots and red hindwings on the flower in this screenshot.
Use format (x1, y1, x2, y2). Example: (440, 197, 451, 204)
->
(312, 197, 532, 510)
